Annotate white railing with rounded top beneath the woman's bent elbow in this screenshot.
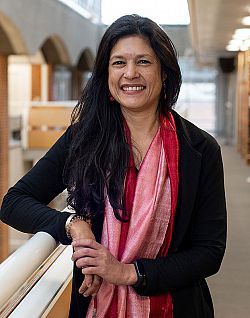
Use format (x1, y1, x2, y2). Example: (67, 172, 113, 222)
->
(0, 232, 72, 318)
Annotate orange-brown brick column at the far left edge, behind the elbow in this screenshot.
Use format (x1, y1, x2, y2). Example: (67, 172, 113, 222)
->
(0, 55, 9, 262)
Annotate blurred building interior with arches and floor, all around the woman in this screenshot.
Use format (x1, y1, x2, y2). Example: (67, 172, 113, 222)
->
(0, 0, 250, 318)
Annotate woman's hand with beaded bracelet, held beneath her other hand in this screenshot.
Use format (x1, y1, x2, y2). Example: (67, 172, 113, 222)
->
(70, 220, 102, 297)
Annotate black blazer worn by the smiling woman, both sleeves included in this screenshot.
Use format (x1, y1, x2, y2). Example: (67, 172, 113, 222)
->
(0, 111, 226, 318)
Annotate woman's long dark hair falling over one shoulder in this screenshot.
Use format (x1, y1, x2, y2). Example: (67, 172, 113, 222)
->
(65, 15, 181, 220)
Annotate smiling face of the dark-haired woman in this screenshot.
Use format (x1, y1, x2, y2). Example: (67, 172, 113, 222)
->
(108, 36, 163, 111)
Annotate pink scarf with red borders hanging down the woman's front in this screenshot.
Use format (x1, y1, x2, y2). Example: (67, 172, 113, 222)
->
(87, 115, 178, 318)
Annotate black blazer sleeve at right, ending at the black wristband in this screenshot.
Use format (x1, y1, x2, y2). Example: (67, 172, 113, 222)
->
(136, 139, 226, 296)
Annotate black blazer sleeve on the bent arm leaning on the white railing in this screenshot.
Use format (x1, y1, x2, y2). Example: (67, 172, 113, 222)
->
(0, 128, 71, 244)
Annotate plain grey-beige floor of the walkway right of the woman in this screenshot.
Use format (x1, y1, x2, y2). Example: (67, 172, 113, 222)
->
(208, 145, 250, 318)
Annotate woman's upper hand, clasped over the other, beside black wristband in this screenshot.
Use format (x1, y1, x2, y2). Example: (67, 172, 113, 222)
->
(72, 239, 137, 285)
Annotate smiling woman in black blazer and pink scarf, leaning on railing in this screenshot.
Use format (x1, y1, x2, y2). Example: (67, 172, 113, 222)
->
(1, 15, 226, 318)
